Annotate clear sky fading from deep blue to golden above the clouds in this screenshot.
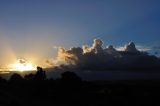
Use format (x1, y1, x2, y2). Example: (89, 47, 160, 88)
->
(0, 0, 160, 64)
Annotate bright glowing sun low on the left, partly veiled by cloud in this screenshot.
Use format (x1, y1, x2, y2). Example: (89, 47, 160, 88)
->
(10, 59, 36, 72)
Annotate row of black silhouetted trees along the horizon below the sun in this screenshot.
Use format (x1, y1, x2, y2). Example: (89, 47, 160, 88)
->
(0, 67, 82, 83)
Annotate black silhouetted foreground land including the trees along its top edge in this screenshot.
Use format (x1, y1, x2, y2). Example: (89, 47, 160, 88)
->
(0, 69, 160, 106)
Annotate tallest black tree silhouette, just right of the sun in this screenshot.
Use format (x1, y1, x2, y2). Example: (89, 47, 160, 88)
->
(35, 67, 46, 80)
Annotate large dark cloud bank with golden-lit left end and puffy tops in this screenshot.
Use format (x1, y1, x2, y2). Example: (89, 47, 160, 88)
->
(49, 39, 160, 70)
